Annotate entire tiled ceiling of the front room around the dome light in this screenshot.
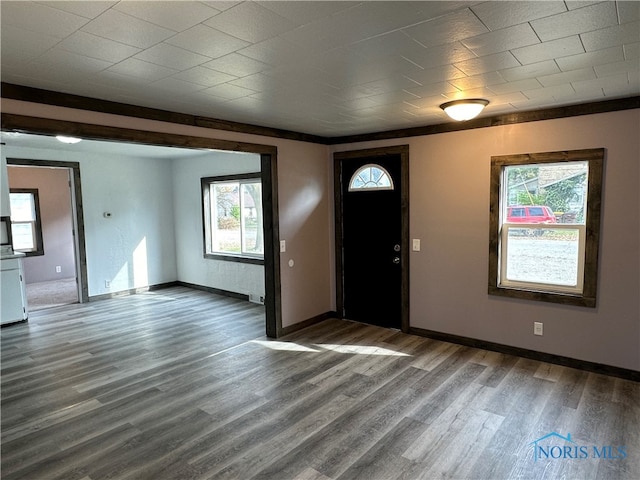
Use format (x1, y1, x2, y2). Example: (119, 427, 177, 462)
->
(0, 0, 640, 136)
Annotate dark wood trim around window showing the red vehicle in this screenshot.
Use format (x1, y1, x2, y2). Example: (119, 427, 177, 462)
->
(488, 148, 605, 308)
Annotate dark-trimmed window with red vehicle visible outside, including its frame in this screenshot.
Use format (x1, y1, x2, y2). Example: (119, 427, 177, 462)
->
(489, 149, 604, 307)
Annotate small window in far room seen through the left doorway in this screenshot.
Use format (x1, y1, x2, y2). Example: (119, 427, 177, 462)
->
(9, 188, 44, 256)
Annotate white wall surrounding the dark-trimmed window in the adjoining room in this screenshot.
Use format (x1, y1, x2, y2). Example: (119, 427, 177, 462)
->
(171, 152, 265, 296)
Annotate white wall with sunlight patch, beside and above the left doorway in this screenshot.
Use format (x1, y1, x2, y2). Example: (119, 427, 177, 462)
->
(3, 146, 177, 297)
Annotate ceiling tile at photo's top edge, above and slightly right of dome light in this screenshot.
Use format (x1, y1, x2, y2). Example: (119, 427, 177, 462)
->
(471, 0, 567, 30)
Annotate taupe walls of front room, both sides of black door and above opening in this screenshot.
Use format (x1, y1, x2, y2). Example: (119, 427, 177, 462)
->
(3, 99, 640, 371)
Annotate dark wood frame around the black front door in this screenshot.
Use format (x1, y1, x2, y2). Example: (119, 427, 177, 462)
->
(333, 145, 409, 333)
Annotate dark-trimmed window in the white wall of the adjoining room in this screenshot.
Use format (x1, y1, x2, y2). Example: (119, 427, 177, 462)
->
(201, 173, 264, 263)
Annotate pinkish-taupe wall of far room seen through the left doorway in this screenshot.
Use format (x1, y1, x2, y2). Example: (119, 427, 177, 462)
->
(8, 166, 76, 283)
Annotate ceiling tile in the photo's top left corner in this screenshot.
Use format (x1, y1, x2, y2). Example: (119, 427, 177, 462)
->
(0, 2, 88, 38)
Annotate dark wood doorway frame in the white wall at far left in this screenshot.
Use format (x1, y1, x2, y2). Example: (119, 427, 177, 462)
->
(7, 158, 89, 303)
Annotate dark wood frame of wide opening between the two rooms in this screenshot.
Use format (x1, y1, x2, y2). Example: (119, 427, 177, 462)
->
(1, 113, 284, 338)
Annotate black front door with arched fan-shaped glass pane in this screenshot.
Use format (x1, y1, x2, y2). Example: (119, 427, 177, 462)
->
(336, 148, 408, 328)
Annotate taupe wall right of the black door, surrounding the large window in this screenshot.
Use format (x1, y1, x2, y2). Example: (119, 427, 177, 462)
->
(335, 110, 640, 370)
